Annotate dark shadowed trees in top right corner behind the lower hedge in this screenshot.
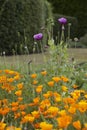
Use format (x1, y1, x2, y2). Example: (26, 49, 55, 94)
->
(48, 0, 87, 38)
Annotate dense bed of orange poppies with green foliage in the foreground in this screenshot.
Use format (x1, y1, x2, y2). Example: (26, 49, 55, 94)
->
(0, 70, 87, 130)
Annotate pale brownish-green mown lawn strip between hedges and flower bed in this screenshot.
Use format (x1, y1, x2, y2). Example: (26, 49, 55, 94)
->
(0, 48, 87, 65)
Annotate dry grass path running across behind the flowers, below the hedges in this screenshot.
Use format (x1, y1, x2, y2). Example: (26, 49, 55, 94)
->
(0, 48, 87, 71)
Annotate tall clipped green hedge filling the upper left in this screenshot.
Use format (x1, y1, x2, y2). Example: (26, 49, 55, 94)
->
(0, 0, 51, 55)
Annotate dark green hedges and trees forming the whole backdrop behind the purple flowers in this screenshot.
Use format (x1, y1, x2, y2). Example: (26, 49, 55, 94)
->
(0, 0, 87, 55)
